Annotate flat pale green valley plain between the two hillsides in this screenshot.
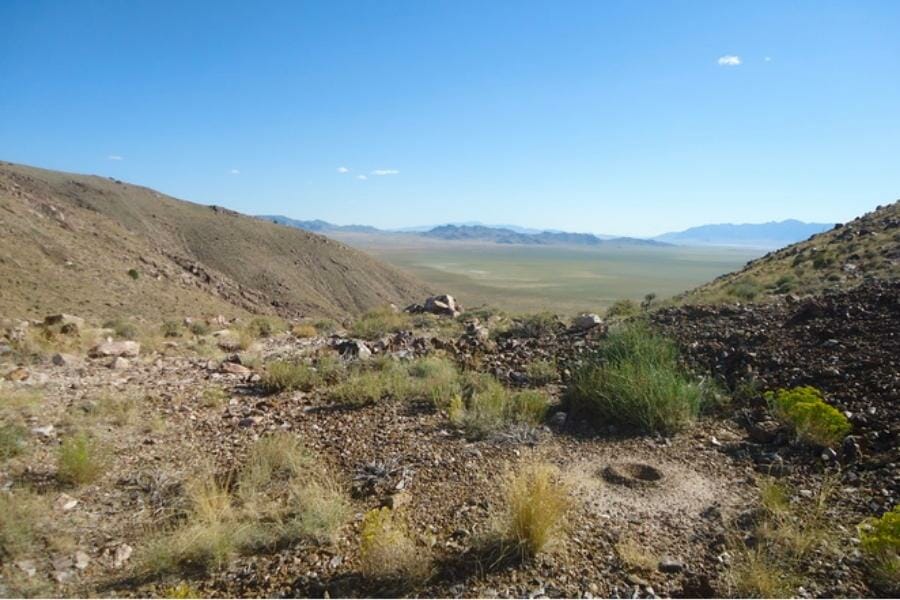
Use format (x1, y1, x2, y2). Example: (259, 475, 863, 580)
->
(328, 232, 765, 314)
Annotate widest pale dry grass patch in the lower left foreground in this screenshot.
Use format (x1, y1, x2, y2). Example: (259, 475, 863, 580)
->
(138, 433, 350, 575)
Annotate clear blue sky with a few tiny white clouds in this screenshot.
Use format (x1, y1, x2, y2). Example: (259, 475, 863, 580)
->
(0, 0, 900, 235)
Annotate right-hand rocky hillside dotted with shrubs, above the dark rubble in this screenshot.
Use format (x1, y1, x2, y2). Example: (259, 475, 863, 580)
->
(676, 201, 900, 304)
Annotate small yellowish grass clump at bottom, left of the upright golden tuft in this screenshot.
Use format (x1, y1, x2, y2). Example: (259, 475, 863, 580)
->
(359, 507, 430, 587)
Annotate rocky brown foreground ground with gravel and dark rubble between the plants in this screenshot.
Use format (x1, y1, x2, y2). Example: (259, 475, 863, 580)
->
(0, 284, 900, 598)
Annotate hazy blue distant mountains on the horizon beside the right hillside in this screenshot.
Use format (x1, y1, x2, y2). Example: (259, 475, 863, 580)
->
(653, 219, 834, 248)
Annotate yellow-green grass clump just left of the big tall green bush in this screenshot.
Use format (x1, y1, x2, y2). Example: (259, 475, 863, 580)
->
(448, 373, 550, 440)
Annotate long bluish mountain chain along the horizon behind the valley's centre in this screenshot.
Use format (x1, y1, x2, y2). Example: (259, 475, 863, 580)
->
(259, 215, 671, 246)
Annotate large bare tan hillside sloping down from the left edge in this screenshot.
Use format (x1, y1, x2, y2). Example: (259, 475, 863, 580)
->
(0, 163, 427, 319)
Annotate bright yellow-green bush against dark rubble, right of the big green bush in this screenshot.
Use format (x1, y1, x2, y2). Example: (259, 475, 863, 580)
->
(765, 386, 851, 446)
